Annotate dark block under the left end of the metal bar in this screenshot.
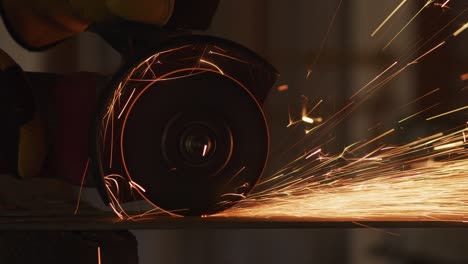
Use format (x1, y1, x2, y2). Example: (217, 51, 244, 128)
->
(0, 231, 138, 264)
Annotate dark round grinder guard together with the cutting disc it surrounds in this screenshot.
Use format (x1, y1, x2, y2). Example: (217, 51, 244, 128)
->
(93, 35, 277, 218)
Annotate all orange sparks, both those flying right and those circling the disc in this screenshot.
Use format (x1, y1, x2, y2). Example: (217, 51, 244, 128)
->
(89, 0, 468, 222)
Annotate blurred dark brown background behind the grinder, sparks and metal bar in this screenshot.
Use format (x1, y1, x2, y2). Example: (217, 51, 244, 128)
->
(0, 0, 468, 264)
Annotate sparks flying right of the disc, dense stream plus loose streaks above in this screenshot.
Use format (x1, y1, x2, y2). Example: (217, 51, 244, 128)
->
(215, 1, 468, 223)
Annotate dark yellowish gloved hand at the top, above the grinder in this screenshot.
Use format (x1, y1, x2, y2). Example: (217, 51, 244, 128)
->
(1, 0, 174, 50)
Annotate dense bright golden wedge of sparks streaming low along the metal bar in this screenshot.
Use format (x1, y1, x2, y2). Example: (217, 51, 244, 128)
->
(217, 129, 468, 221)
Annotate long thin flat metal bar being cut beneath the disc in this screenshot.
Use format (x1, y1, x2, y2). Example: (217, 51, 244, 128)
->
(0, 215, 468, 231)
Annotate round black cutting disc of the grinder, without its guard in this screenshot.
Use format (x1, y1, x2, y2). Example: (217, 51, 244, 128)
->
(123, 72, 268, 215)
